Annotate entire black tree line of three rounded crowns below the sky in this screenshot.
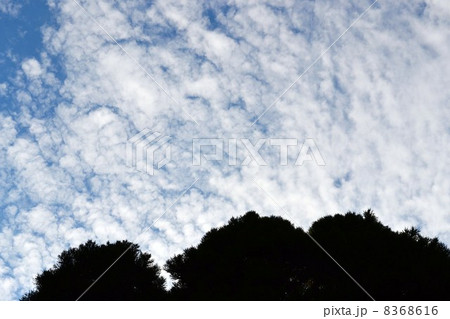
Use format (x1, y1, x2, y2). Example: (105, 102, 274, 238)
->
(22, 210, 450, 300)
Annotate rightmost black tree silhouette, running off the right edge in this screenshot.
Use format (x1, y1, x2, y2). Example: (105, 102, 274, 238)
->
(309, 210, 450, 300)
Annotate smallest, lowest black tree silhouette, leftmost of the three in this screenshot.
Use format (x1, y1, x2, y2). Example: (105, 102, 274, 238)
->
(22, 241, 166, 300)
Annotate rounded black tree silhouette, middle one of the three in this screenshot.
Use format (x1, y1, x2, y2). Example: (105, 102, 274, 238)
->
(165, 212, 320, 300)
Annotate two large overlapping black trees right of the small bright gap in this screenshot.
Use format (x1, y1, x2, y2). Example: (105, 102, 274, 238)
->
(165, 210, 450, 300)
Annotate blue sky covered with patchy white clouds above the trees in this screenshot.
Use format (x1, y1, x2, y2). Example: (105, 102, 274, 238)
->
(0, 0, 450, 300)
